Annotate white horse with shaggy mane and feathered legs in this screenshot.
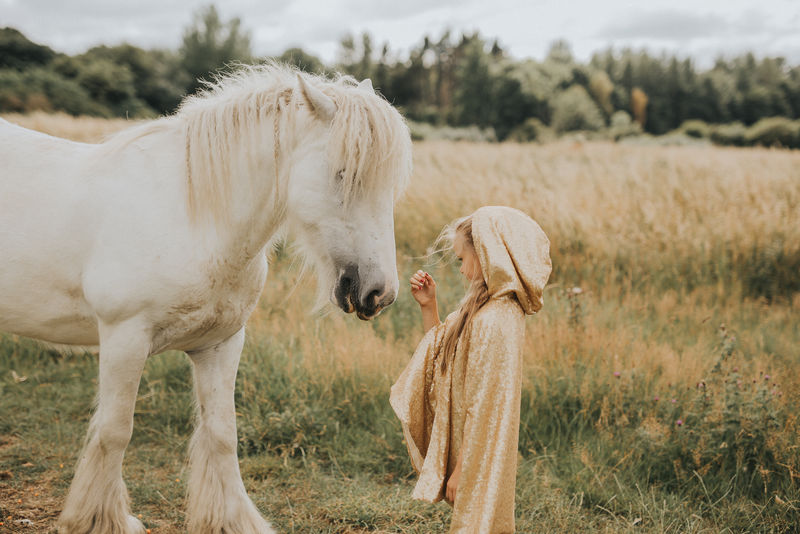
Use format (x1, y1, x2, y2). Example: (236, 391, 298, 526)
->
(0, 64, 411, 534)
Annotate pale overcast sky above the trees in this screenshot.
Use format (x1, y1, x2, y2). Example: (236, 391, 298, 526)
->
(0, 0, 800, 67)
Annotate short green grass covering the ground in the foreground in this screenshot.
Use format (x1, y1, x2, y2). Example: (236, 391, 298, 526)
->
(0, 288, 800, 533)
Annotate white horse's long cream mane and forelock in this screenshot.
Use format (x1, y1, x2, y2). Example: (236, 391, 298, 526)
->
(175, 62, 411, 226)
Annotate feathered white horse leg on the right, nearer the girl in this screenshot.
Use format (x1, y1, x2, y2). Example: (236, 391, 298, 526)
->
(186, 329, 274, 534)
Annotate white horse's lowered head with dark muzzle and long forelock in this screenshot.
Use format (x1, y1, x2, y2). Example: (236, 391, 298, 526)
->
(287, 75, 411, 320)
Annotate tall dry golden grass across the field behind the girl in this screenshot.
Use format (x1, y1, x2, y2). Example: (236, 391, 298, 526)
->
(5, 113, 800, 398)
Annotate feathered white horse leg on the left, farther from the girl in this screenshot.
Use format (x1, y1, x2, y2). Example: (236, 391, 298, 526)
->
(58, 322, 150, 534)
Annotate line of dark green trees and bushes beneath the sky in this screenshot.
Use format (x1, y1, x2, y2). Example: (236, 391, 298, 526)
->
(0, 6, 800, 147)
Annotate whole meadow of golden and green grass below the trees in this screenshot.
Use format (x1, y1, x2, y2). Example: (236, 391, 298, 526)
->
(0, 115, 800, 533)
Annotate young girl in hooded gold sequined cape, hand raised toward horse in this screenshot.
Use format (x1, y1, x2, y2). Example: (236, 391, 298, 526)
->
(390, 206, 551, 534)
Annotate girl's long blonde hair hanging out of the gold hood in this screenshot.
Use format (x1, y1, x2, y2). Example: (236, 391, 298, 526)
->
(436, 216, 489, 373)
